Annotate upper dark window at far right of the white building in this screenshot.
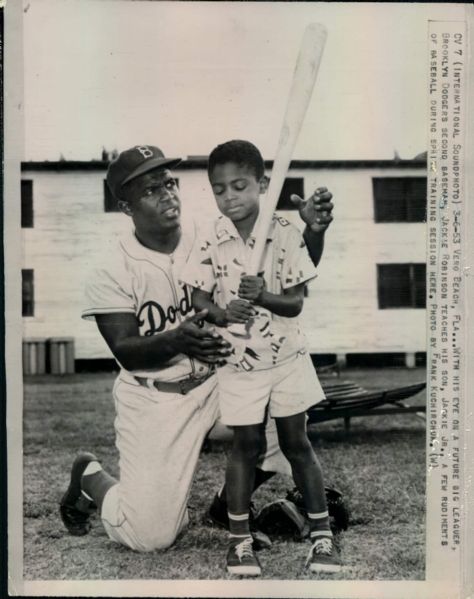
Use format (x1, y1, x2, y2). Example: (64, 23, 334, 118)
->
(372, 177, 427, 223)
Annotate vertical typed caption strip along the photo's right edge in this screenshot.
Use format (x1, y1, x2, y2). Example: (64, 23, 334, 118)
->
(427, 21, 468, 582)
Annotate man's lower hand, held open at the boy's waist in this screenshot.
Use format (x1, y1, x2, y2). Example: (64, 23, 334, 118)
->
(174, 310, 231, 364)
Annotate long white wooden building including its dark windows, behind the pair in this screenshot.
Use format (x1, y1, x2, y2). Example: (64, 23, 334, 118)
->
(22, 157, 426, 365)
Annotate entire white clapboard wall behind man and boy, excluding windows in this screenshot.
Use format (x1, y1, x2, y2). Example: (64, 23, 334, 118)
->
(22, 163, 426, 359)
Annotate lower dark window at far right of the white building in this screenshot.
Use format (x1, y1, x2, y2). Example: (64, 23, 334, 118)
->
(377, 264, 426, 310)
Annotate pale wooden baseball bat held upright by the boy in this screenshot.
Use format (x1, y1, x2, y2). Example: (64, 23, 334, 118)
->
(229, 23, 327, 336)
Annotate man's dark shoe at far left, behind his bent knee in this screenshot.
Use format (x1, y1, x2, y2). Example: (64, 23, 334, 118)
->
(59, 453, 98, 537)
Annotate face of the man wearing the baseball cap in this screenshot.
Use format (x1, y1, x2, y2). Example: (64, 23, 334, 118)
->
(123, 169, 181, 233)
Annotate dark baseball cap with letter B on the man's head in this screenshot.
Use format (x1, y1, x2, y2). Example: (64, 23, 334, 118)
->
(107, 146, 181, 198)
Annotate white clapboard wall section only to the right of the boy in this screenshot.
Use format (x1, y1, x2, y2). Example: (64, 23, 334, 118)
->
(284, 168, 426, 354)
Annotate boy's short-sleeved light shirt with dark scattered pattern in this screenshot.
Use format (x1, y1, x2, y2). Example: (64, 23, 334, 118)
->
(181, 215, 316, 371)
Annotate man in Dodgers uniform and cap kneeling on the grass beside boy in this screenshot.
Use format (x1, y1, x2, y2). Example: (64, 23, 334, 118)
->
(60, 145, 333, 564)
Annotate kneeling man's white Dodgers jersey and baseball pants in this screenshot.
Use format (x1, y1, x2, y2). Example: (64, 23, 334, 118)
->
(82, 221, 290, 551)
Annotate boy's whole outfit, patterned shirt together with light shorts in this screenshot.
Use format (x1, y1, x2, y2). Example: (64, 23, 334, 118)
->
(182, 215, 324, 425)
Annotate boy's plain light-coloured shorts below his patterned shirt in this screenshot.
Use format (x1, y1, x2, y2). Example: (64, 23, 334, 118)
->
(217, 352, 325, 426)
